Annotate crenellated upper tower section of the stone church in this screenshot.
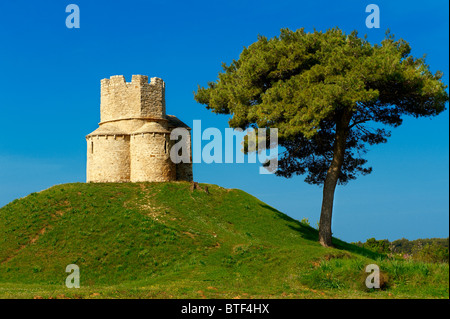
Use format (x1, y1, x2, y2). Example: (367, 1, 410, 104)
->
(100, 74, 166, 122)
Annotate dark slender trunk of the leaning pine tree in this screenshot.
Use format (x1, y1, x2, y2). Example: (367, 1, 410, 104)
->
(319, 114, 351, 247)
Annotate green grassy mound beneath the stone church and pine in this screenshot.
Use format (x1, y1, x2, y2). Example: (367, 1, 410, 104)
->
(0, 182, 449, 298)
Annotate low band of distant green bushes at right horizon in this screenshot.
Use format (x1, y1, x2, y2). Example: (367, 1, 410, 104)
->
(353, 238, 449, 263)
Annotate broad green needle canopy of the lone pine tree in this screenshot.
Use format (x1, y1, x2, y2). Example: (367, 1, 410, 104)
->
(195, 28, 448, 184)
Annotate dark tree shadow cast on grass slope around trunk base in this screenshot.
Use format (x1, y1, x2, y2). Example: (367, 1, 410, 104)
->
(260, 204, 383, 259)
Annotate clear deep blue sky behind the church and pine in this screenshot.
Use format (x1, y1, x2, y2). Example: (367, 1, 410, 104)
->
(0, 0, 449, 241)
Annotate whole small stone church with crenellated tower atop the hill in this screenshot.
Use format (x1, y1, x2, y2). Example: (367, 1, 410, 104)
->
(86, 75, 193, 182)
